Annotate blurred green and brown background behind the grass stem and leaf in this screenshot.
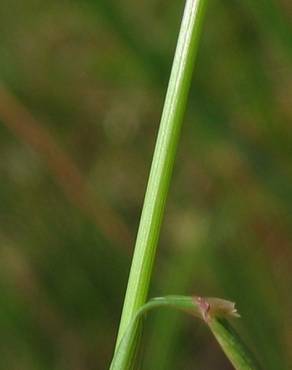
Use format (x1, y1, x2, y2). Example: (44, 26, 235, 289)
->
(0, 0, 292, 370)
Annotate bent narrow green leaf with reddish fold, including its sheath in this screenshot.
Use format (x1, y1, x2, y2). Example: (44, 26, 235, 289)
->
(110, 296, 260, 370)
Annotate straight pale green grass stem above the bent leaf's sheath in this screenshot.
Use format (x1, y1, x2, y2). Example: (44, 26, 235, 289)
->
(116, 0, 206, 348)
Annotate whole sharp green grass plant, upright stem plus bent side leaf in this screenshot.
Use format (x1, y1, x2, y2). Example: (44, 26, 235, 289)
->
(111, 0, 258, 370)
